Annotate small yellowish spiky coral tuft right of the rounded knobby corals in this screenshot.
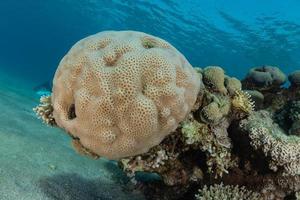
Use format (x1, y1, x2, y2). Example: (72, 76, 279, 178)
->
(231, 90, 254, 114)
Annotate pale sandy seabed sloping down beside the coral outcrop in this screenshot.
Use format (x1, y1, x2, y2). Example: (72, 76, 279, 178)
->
(0, 74, 144, 200)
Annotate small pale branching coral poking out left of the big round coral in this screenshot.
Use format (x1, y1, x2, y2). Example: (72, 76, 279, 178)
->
(33, 95, 56, 126)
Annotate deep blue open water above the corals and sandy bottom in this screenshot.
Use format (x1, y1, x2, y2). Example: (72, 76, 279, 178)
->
(0, 0, 300, 84)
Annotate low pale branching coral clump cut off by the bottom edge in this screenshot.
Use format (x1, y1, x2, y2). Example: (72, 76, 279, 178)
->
(195, 183, 263, 200)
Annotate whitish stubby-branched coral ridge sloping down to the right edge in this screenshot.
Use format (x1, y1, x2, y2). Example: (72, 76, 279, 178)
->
(240, 111, 300, 175)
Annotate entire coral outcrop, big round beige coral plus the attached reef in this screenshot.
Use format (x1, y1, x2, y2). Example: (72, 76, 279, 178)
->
(34, 31, 300, 200)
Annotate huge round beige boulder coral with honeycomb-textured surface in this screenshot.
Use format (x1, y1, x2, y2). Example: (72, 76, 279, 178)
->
(52, 31, 200, 159)
